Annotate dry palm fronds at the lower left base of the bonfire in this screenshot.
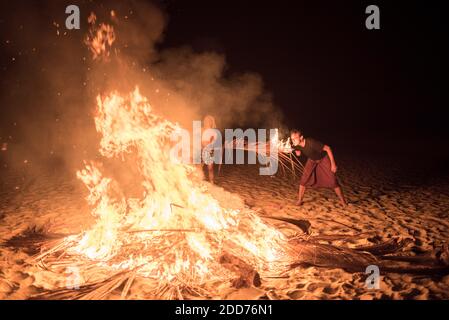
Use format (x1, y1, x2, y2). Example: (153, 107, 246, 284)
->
(20, 228, 242, 300)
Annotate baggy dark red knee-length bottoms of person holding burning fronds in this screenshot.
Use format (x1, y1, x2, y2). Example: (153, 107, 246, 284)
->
(299, 156, 339, 189)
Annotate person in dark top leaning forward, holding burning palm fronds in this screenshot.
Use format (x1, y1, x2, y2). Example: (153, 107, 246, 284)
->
(290, 130, 346, 206)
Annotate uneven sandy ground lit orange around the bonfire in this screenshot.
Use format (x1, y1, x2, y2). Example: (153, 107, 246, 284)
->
(0, 152, 449, 299)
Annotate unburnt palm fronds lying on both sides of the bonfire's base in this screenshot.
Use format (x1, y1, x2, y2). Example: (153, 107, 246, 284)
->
(2, 217, 449, 300)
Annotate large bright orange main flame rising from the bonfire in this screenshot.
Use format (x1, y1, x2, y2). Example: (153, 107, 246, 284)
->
(70, 89, 289, 283)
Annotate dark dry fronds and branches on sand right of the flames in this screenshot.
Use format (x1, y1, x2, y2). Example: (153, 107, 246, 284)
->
(256, 216, 449, 275)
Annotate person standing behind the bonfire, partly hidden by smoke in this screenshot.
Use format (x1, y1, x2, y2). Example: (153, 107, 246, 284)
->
(201, 115, 217, 184)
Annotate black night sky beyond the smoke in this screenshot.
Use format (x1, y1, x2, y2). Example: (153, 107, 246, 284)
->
(1, 0, 449, 158)
